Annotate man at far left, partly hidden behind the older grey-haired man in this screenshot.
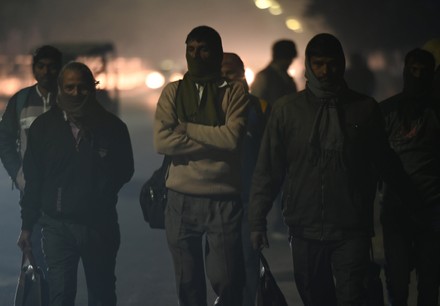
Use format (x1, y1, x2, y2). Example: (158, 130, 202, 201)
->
(0, 45, 62, 270)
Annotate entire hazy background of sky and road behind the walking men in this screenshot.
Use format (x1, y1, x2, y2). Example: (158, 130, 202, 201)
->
(0, 0, 440, 306)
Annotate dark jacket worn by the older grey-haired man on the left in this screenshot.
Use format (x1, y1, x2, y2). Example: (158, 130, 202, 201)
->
(21, 106, 134, 229)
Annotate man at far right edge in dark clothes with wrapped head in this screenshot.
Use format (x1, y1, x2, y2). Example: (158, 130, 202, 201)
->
(380, 48, 440, 306)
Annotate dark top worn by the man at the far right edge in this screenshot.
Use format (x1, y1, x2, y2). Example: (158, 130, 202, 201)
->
(380, 93, 440, 228)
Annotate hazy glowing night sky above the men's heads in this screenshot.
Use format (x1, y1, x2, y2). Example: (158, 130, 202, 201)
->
(0, 0, 440, 100)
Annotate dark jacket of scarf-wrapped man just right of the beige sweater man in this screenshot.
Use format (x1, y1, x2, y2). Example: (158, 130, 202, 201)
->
(249, 89, 408, 240)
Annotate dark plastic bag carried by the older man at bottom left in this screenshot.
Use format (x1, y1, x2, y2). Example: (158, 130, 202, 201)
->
(14, 253, 49, 306)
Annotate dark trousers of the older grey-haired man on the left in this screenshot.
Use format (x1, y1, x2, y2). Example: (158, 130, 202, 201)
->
(40, 216, 120, 306)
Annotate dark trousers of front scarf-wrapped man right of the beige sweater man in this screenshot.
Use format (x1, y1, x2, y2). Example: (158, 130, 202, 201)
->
(290, 236, 370, 306)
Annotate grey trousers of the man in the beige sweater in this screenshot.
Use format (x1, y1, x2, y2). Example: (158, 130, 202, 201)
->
(165, 190, 244, 306)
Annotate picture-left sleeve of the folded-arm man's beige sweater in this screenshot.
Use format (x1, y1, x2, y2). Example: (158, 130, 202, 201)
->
(153, 82, 209, 156)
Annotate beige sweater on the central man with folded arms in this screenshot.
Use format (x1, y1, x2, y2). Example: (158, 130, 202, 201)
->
(154, 77, 248, 195)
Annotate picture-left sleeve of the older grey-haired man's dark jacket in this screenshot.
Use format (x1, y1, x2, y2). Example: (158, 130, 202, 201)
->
(20, 120, 43, 230)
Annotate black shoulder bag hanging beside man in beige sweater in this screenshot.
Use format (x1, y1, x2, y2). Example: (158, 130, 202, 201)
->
(139, 156, 171, 229)
